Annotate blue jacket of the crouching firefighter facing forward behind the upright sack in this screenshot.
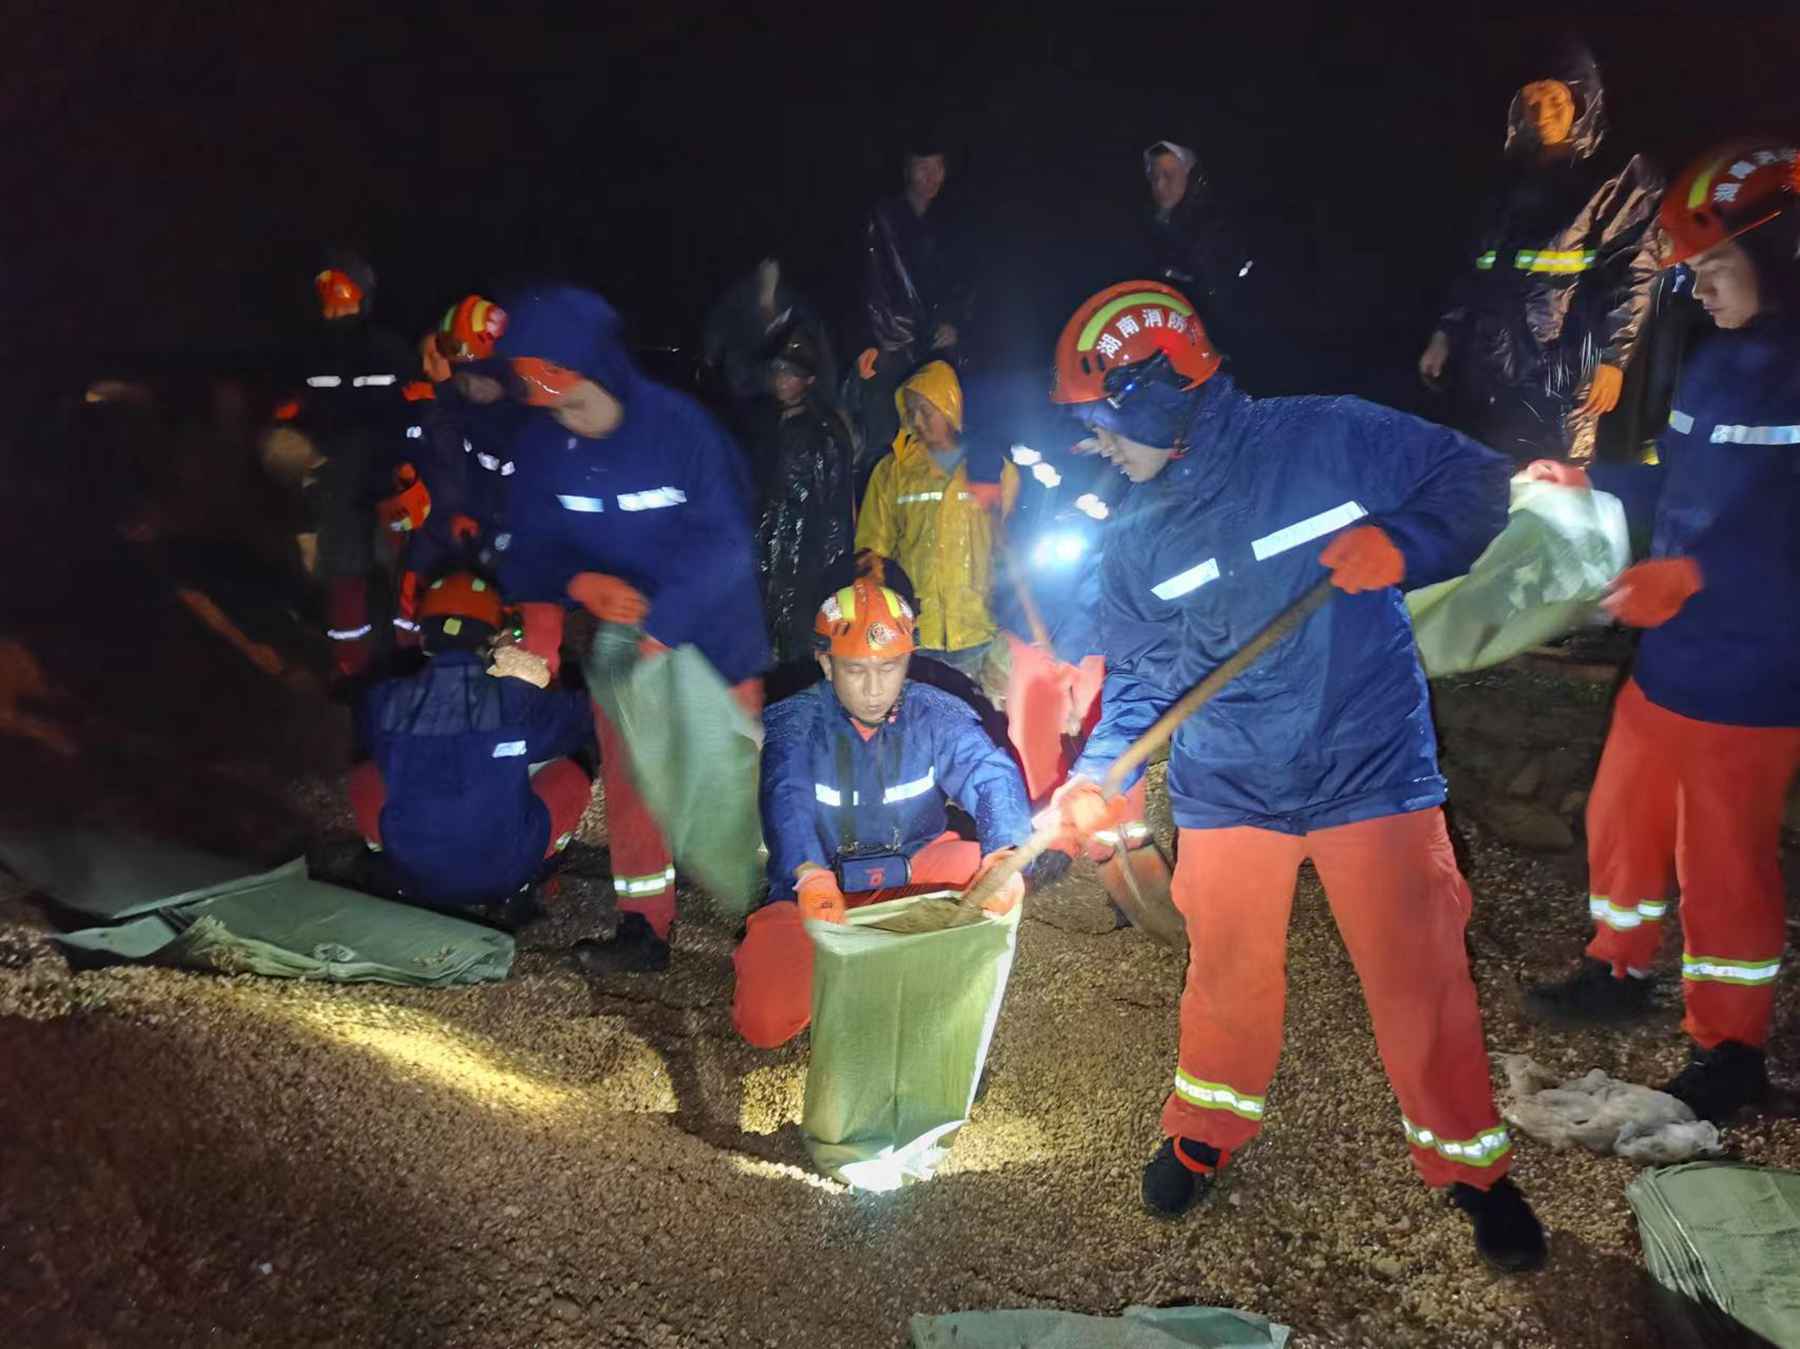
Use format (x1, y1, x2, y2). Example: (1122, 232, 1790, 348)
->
(763, 679, 1031, 901)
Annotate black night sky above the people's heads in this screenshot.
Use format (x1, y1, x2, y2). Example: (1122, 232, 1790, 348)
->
(10, 0, 1800, 399)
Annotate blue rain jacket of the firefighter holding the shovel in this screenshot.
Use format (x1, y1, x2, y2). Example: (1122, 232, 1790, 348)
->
(1073, 373, 1508, 834)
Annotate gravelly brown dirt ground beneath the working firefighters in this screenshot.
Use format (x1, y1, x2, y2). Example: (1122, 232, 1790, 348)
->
(0, 540, 1800, 1349)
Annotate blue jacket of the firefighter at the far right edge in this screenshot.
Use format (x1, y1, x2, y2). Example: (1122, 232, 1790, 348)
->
(1589, 319, 1800, 726)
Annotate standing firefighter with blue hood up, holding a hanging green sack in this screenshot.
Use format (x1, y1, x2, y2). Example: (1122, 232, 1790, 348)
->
(473, 286, 769, 974)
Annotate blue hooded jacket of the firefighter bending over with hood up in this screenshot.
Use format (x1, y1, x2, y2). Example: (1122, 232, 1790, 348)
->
(499, 286, 769, 683)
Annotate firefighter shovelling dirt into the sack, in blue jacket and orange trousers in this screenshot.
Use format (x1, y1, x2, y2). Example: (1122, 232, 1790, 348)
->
(1051, 281, 1544, 1270)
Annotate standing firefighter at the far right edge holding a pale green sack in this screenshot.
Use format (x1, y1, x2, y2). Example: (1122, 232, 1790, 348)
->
(1526, 140, 1800, 1122)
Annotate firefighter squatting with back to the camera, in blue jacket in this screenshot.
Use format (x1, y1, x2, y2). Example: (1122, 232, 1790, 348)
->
(349, 573, 594, 906)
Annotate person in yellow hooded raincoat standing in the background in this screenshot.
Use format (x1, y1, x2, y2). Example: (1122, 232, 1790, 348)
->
(857, 360, 1019, 683)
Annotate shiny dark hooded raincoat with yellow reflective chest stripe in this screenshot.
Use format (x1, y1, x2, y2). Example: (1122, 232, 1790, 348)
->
(1438, 47, 1665, 461)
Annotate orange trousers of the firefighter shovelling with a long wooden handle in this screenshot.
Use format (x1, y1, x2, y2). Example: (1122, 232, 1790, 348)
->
(1163, 809, 1510, 1189)
